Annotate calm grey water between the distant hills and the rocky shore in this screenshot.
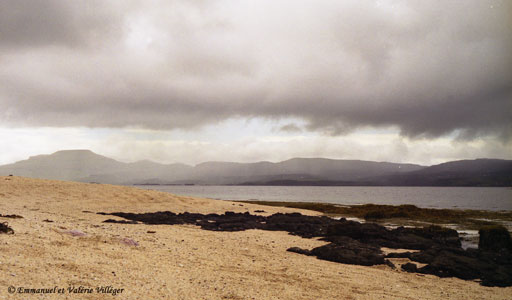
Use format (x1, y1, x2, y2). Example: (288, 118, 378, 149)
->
(133, 185, 512, 210)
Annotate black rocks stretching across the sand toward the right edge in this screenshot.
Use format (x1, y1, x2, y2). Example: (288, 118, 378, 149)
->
(102, 211, 512, 286)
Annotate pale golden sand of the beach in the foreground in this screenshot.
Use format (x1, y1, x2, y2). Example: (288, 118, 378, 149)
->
(0, 177, 512, 299)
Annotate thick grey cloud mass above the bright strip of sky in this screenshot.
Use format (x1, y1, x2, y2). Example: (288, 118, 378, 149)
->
(0, 0, 512, 139)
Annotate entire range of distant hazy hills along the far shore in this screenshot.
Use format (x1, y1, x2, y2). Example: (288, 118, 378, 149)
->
(0, 150, 512, 186)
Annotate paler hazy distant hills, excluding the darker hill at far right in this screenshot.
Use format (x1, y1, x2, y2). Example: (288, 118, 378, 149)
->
(0, 150, 423, 184)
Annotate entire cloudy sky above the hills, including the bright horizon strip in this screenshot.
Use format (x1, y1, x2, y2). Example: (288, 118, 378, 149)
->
(0, 0, 512, 165)
